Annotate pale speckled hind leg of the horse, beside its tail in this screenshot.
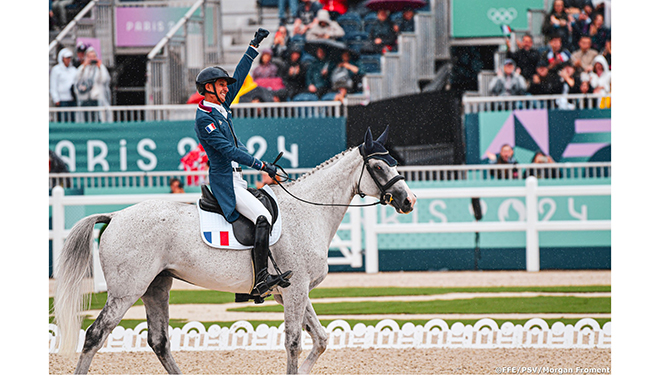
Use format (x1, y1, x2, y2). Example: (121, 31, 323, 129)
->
(75, 293, 140, 374)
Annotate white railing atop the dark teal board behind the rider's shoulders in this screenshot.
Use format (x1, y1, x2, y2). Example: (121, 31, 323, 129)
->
(48, 101, 347, 123)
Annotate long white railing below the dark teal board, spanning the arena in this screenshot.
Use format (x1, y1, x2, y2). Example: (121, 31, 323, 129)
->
(48, 162, 612, 189)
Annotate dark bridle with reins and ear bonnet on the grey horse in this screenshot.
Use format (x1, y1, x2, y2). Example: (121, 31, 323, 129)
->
(272, 149, 405, 207)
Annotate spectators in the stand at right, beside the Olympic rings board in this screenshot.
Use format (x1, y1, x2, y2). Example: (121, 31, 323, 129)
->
(488, 0, 612, 101)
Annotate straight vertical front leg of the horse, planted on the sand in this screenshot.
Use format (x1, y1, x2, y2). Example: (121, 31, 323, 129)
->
(282, 286, 309, 374)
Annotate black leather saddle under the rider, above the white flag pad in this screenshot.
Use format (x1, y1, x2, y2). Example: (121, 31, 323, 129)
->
(199, 185, 279, 246)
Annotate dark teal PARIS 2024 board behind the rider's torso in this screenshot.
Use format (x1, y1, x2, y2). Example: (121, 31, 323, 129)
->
(49, 117, 346, 172)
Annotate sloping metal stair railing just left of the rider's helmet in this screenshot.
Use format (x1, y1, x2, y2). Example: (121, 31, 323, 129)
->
(145, 0, 223, 105)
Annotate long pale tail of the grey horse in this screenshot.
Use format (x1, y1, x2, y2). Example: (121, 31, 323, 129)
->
(54, 214, 112, 355)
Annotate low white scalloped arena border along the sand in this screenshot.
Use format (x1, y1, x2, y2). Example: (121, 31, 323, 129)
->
(48, 318, 612, 353)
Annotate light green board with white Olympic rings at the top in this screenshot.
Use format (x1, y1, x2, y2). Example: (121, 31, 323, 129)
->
(451, 0, 543, 38)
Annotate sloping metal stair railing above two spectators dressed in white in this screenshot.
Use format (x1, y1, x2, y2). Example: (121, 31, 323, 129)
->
(48, 0, 115, 67)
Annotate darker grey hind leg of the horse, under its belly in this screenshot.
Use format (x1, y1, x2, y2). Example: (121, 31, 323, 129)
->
(142, 276, 181, 374)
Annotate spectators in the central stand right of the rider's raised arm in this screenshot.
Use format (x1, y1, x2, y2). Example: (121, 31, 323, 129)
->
(242, 0, 428, 101)
